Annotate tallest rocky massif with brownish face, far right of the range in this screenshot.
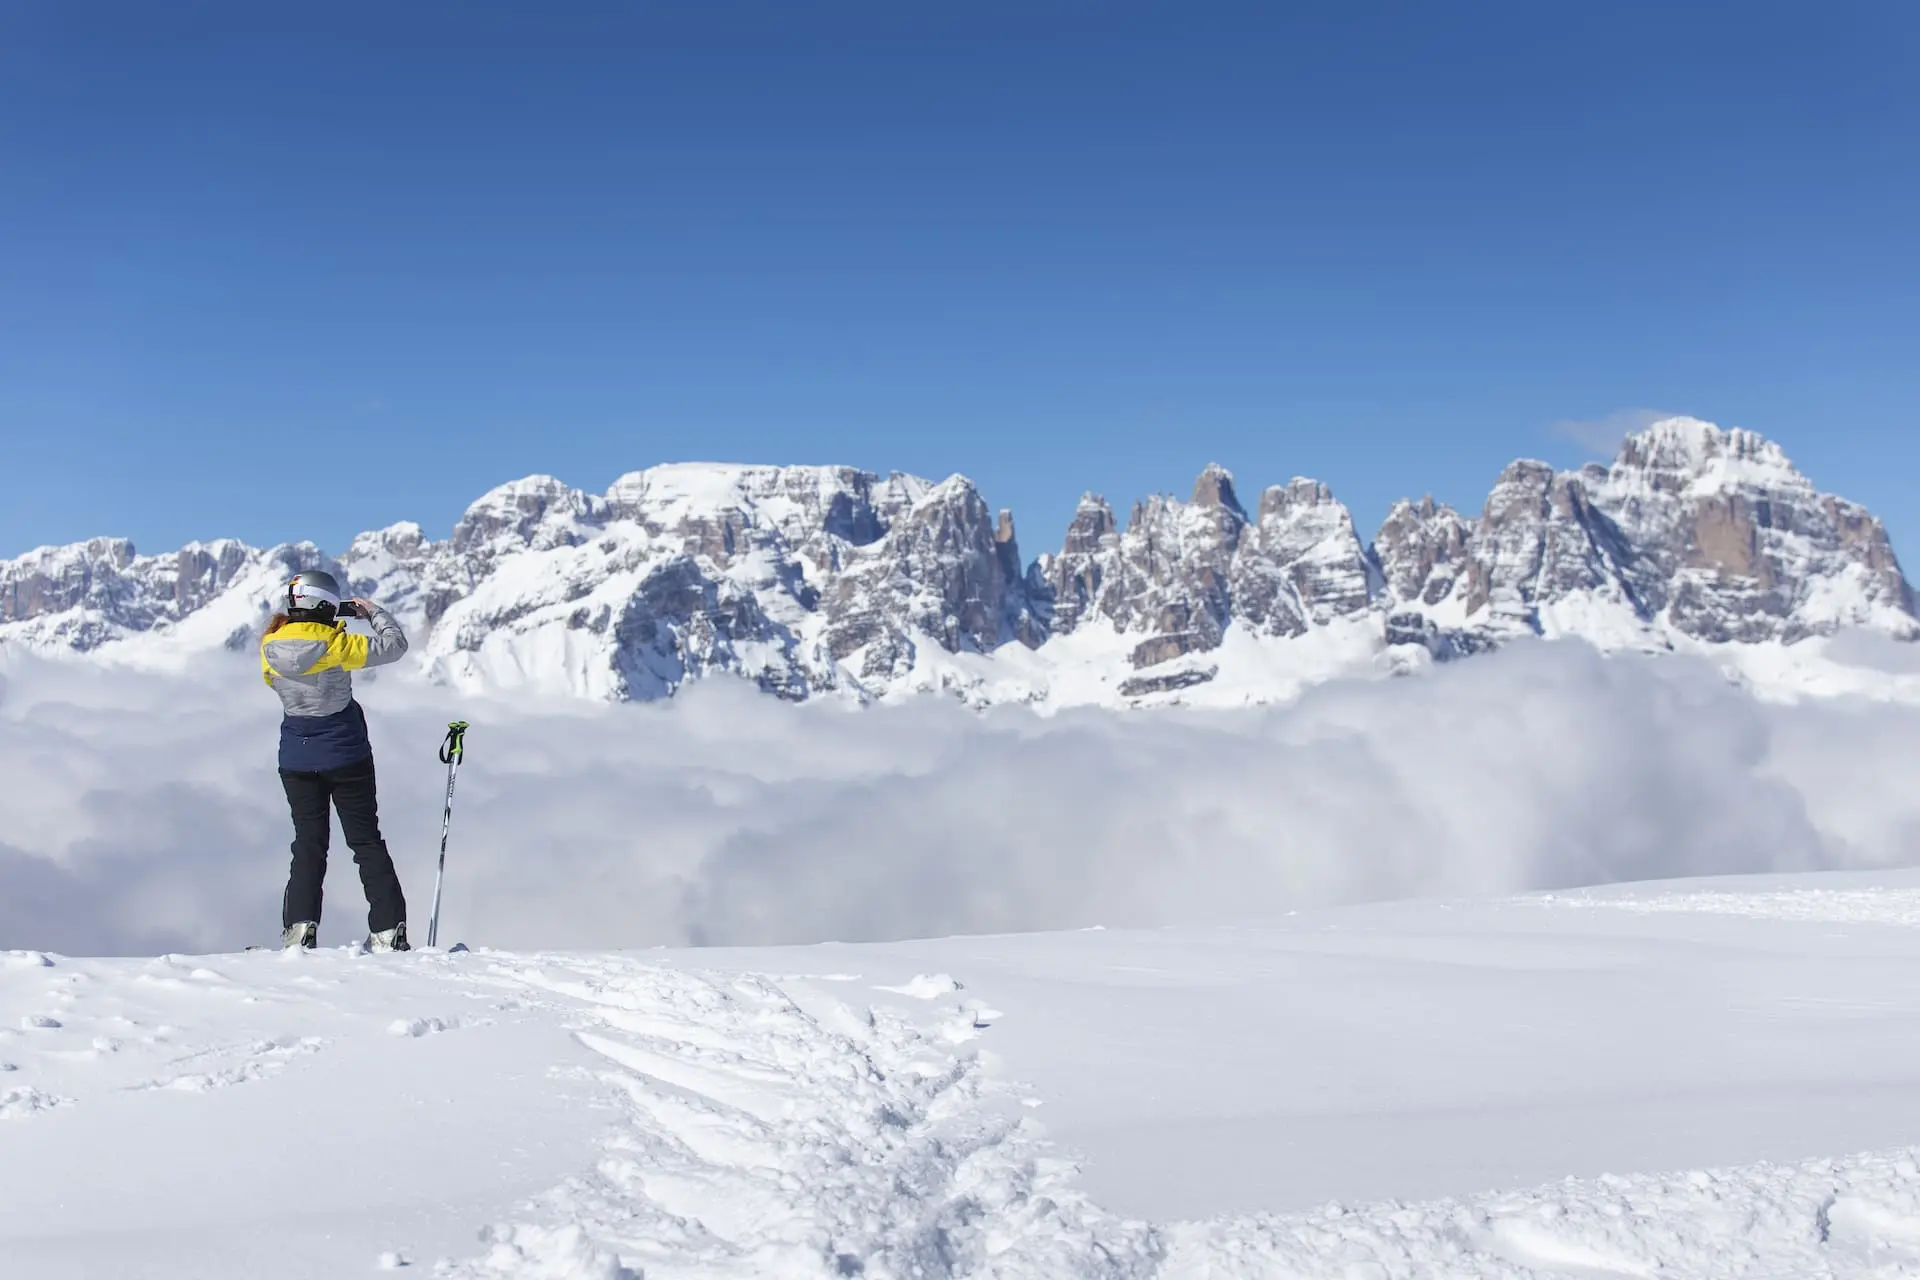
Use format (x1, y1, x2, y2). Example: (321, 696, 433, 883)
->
(1375, 418, 1920, 656)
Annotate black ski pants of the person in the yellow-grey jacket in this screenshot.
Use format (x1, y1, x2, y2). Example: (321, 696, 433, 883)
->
(280, 756, 407, 933)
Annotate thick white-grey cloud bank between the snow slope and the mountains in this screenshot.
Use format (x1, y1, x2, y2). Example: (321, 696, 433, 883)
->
(0, 643, 1920, 954)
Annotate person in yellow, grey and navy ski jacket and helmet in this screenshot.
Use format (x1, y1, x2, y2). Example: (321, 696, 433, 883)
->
(259, 570, 409, 952)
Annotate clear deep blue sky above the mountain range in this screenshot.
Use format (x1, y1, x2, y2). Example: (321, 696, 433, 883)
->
(0, 0, 1920, 560)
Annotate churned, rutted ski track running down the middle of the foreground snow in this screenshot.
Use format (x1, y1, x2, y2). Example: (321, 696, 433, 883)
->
(440, 956, 1162, 1280)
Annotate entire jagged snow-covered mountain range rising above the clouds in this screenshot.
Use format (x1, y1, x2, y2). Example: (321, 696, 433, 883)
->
(0, 418, 1920, 704)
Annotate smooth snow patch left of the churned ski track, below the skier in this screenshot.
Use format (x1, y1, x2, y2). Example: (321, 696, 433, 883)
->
(0, 948, 605, 1280)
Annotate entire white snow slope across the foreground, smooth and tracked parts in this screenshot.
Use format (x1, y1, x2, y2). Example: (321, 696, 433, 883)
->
(0, 873, 1920, 1280)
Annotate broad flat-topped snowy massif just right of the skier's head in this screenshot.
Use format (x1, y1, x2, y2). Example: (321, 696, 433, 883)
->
(332, 464, 1046, 699)
